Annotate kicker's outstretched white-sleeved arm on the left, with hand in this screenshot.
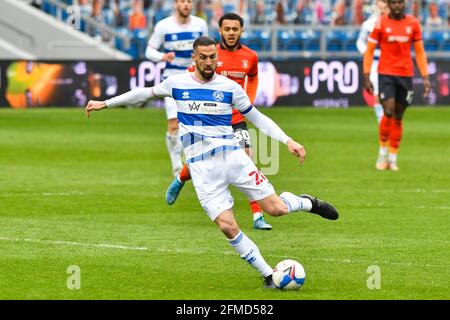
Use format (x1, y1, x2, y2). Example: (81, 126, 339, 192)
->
(85, 88, 154, 118)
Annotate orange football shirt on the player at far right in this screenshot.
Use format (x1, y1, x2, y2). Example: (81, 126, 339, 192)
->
(368, 14, 422, 77)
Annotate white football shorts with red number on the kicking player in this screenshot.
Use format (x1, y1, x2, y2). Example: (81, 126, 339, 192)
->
(189, 149, 275, 221)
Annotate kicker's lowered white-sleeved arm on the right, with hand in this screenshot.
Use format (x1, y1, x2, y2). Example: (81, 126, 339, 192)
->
(243, 106, 306, 163)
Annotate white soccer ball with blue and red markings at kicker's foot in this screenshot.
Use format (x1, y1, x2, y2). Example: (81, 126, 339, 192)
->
(272, 259, 305, 290)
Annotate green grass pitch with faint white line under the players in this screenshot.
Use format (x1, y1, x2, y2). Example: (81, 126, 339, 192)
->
(0, 108, 450, 300)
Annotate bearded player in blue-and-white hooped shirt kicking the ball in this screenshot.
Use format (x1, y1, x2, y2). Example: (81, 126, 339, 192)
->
(85, 36, 339, 289)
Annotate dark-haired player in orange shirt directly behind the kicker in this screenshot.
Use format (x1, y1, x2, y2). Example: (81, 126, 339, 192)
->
(166, 13, 272, 230)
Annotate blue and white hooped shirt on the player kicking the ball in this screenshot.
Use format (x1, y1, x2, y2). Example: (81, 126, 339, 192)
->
(152, 73, 252, 163)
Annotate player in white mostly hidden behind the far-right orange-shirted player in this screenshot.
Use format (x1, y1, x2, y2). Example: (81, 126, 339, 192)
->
(356, 0, 389, 123)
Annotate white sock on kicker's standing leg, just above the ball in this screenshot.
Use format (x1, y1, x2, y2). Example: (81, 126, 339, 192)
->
(228, 231, 273, 277)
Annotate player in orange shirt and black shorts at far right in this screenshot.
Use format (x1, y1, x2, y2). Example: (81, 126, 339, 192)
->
(363, 0, 431, 171)
